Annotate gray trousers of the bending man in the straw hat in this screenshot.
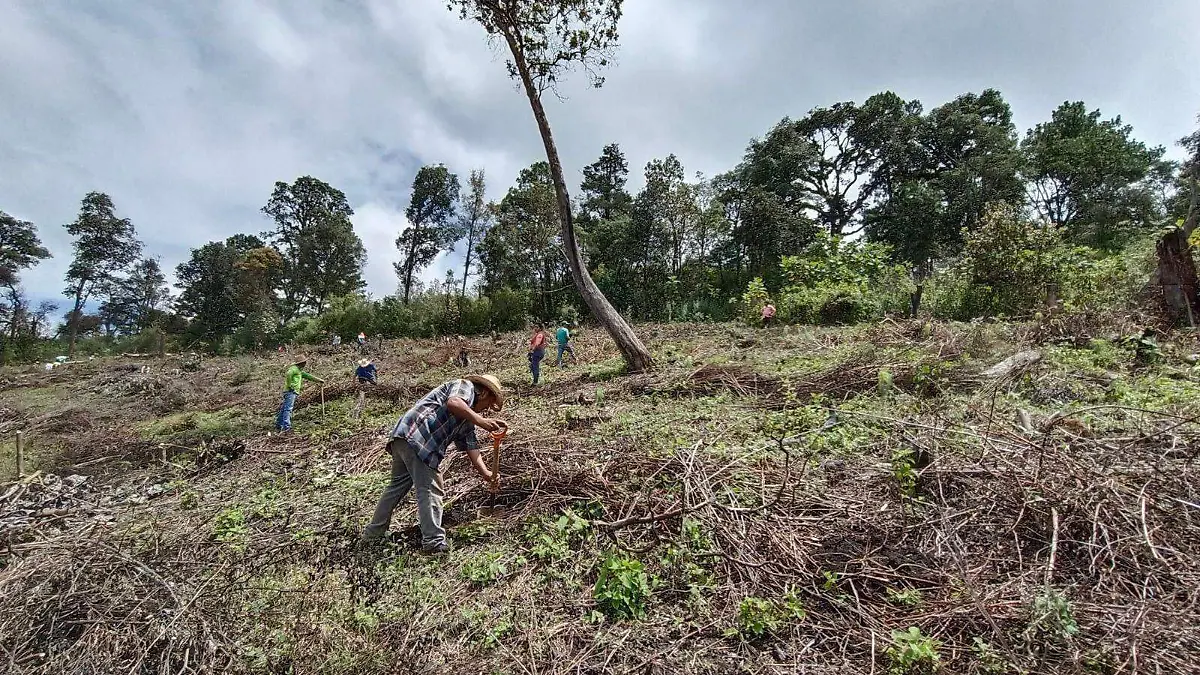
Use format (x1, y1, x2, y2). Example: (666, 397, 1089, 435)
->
(362, 438, 446, 546)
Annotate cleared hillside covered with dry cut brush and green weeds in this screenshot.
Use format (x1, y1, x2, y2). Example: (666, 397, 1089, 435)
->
(0, 321, 1200, 675)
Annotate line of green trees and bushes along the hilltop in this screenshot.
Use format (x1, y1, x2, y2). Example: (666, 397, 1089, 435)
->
(0, 89, 1200, 359)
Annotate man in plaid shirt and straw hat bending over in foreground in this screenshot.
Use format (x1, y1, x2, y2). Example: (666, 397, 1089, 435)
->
(362, 375, 505, 554)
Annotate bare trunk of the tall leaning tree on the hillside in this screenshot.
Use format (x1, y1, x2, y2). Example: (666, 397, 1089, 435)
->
(504, 34, 654, 372)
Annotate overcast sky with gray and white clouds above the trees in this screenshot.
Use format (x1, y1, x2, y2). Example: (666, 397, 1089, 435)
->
(0, 0, 1200, 307)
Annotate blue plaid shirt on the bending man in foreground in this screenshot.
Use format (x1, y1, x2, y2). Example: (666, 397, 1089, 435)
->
(391, 380, 479, 471)
